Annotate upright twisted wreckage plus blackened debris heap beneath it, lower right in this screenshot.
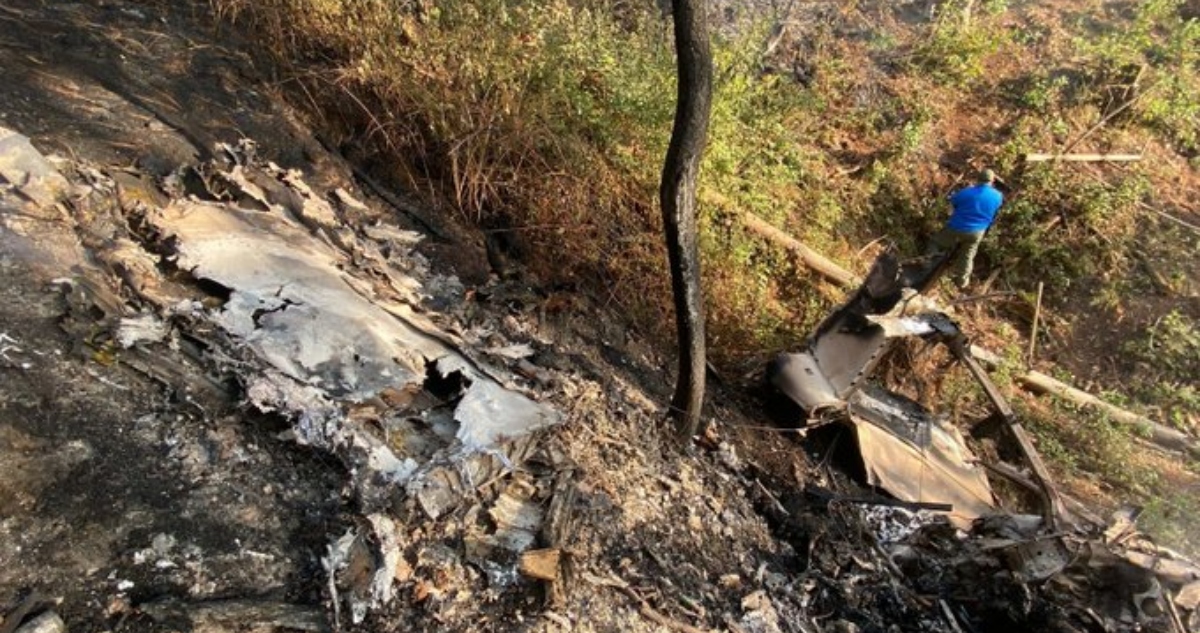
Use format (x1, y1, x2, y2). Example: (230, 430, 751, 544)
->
(767, 252, 1200, 632)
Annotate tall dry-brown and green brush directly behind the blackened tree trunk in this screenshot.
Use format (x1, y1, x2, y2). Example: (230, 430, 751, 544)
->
(215, 0, 842, 355)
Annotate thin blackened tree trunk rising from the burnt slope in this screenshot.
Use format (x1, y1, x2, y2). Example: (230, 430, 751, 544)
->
(659, 0, 713, 438)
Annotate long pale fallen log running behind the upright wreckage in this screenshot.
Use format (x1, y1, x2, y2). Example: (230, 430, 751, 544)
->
(742, 213, 1200, 456)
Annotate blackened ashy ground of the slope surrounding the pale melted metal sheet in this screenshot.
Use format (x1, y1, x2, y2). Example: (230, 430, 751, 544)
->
(0, 0, 1195, 633)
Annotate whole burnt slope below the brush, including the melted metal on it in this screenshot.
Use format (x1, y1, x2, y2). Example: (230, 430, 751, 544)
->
(0, 1, 1196, 633)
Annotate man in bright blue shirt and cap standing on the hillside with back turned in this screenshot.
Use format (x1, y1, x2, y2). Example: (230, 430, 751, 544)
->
(925, 169, 1004, 289)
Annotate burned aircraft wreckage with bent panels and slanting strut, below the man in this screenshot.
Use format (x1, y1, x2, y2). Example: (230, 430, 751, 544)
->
(766, 251, 1200, 632)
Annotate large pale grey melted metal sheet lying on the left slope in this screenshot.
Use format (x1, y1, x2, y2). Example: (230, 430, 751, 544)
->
(151, 200, 560, 452)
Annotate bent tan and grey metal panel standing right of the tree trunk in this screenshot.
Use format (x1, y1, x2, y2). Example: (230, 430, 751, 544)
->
(768, 254, 994, 528)
